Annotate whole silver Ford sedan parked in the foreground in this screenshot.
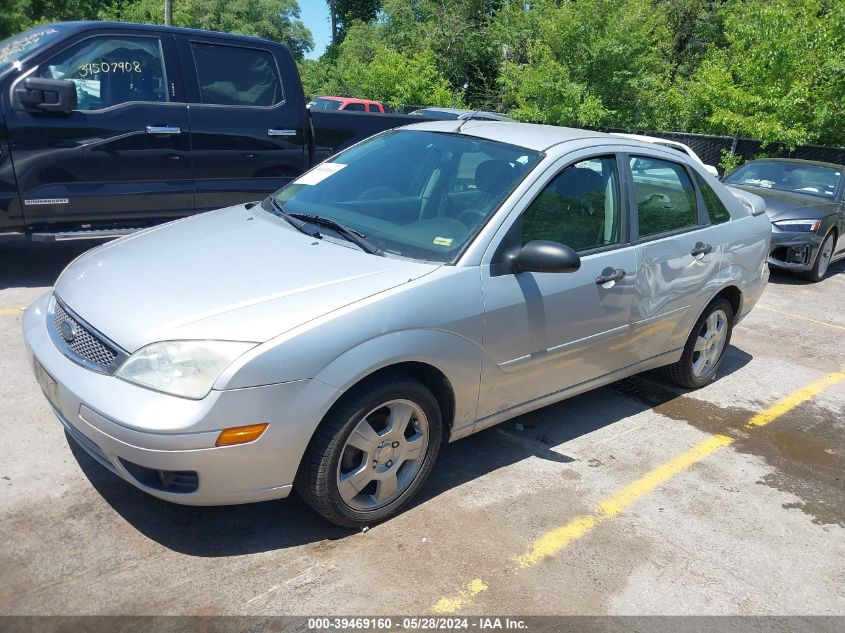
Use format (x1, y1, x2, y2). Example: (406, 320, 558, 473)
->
(23, 121, 771, 526)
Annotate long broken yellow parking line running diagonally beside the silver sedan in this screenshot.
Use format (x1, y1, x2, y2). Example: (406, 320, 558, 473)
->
(432, 371, 845, 614)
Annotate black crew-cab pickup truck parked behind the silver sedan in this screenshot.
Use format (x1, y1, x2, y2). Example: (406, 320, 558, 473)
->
(0, 22, 410, 240)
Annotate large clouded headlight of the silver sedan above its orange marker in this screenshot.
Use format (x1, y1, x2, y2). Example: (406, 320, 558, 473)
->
(115, 341, 256, 400)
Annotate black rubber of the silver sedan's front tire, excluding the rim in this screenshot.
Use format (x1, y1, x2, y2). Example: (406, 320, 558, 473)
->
(294, 375, 443, 527)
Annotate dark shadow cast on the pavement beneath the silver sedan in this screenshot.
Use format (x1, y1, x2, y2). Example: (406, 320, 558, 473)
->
(68, 347, 751, 557)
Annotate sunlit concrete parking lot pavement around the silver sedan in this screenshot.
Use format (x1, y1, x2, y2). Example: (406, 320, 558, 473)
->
(0, 243, 845, 615)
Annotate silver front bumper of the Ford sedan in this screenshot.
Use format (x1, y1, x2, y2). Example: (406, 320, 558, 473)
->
(23, 294, 337, 505)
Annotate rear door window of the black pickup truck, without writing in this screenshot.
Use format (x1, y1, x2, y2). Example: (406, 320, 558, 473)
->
(191, 42, 283, 107)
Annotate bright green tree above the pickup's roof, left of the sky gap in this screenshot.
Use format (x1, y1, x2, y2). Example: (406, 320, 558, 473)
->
(101, 0, 314, 59)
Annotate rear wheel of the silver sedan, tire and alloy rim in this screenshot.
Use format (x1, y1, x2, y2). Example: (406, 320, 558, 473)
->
(663, 298, 734, 389)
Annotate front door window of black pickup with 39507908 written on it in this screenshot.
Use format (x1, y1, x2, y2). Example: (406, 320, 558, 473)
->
(34, 36, 167, 110)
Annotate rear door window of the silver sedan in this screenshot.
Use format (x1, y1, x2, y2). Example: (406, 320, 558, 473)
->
(630, 156, 698, 237)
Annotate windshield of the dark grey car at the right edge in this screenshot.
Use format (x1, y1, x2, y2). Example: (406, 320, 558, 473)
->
(725, 161, 842, 198)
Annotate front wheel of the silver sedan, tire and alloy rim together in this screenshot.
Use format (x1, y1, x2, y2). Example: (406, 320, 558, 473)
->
(294, 375, 443, 527)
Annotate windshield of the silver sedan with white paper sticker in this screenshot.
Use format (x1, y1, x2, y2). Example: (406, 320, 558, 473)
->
(262, 130, 543, 263)
